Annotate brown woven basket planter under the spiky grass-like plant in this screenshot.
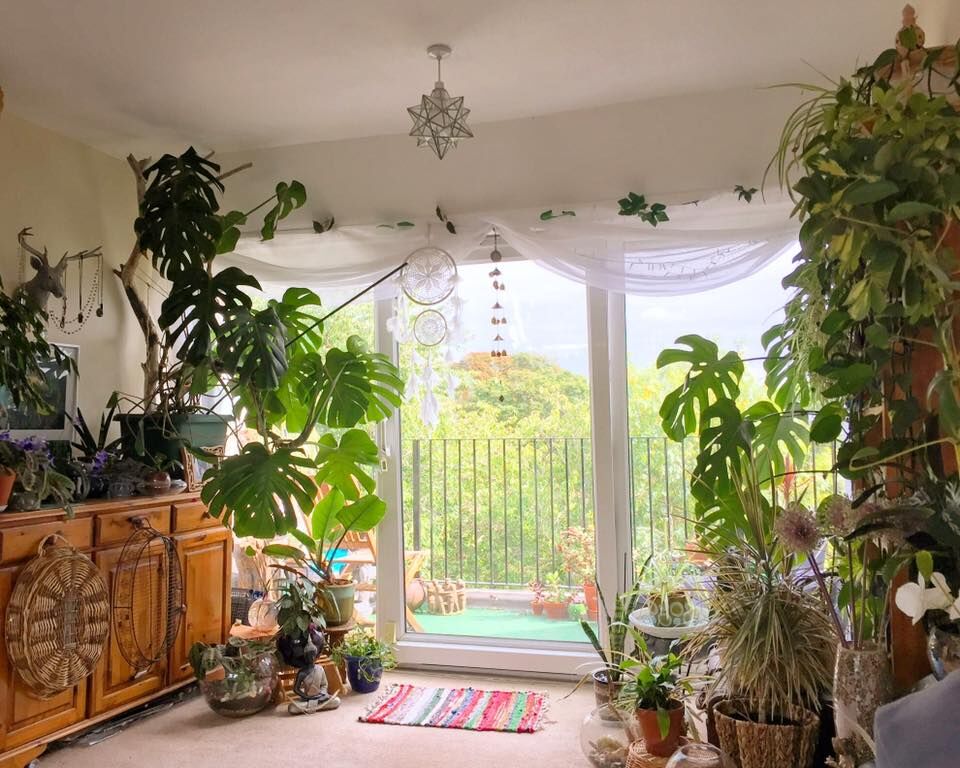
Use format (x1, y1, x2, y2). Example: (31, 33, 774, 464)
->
(713, 699, 820, 768)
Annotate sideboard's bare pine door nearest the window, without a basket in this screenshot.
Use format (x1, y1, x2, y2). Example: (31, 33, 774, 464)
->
(170, 528, 233, 684)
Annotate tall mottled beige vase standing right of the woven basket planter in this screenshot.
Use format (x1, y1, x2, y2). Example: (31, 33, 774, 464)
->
(833, 646, 893, 764)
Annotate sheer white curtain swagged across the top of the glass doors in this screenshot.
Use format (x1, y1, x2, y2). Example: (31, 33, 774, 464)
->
(218, 194, 798, 296)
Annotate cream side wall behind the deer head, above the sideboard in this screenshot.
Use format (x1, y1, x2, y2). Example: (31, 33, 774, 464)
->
(0, 110, 142, 432)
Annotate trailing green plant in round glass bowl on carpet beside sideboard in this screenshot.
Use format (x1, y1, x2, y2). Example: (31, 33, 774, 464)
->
(188, 637, 280, 717)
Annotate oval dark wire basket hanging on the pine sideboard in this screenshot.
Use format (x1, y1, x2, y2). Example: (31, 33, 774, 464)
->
(113, 522, 186, 672)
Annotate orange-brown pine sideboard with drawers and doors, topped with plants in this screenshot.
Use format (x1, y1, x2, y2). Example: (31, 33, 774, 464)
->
(0, 494, 233, 768)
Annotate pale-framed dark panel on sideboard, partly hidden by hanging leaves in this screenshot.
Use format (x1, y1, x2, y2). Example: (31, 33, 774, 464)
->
(0, 344, 79, 441)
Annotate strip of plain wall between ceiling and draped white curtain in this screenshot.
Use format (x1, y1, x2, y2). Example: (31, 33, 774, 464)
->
(217, 86, 804, 226)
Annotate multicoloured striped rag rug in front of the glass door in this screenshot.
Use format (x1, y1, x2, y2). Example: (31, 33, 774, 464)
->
(360, 684, 548, 733)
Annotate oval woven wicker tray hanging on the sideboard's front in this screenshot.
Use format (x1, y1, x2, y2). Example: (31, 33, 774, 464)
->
(6, 534, 110, 699)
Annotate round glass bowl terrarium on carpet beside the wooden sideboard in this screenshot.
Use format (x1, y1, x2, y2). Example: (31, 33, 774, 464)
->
(200, 652, 280, 717)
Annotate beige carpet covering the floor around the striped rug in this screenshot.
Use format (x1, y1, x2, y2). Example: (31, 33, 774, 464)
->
(40, 672, 593, 768)
